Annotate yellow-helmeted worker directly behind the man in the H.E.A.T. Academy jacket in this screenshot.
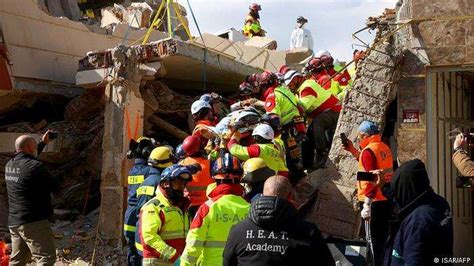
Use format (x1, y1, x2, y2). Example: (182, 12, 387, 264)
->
(240, 158, 276, 202)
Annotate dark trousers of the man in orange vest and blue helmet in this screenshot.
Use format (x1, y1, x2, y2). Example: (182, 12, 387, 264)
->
(359, 200, 392, 266)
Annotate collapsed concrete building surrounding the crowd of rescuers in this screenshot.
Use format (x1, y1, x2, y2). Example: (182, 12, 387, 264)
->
(0, 0, 474, 262)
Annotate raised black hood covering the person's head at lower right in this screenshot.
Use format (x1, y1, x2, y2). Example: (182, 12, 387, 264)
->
(391, 159, 431, 212)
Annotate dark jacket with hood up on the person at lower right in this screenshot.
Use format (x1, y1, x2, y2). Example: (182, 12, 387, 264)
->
(384, 160, 453, 265)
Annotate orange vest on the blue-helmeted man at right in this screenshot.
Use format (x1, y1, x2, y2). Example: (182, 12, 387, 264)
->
(357, 134, 393, 201)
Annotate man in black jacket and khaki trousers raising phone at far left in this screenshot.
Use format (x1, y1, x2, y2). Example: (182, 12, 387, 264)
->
(5, 130, 60, 265)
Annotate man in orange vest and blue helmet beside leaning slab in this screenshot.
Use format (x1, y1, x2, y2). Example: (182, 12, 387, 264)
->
(344, 120, 393, 265)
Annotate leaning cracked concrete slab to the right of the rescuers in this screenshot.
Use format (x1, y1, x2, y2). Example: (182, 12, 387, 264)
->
(307, 19, 401, 239)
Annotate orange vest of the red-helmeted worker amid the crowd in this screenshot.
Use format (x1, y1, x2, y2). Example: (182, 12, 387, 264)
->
(180, 157, 214, 206)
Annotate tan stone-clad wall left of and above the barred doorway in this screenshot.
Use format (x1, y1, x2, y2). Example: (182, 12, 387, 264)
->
(395, 0, 474, 162)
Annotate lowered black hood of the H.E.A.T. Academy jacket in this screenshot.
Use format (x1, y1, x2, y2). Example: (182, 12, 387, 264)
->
(250, 196, 296, 228)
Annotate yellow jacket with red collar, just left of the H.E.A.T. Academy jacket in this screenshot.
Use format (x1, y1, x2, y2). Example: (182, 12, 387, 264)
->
(181, 184, 250, 266)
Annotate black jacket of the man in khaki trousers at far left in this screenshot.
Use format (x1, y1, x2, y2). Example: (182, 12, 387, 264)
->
(5, 144, 59, 226)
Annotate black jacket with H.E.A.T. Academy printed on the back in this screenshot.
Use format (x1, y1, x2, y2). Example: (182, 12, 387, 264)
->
(224, 196, 334, 266)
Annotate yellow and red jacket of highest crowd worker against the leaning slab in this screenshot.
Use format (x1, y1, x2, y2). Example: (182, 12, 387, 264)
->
(298, 79, 341, 118)
